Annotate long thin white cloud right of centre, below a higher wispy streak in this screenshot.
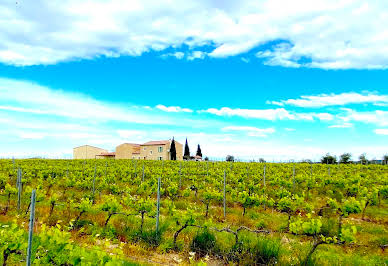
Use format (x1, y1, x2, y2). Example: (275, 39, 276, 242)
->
(202, 107, 333, 121)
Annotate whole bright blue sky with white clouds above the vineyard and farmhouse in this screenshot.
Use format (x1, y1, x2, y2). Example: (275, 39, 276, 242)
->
(0, 0, 388, 161)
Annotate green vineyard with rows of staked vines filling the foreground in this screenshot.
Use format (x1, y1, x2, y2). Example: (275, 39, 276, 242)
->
(0, 159, 388, 265)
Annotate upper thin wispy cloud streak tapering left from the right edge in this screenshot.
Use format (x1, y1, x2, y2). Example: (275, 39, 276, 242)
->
(267, 92, 388, 107)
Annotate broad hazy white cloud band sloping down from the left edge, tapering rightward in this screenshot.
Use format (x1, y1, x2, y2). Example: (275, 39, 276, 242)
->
(0, 78, 172, 124)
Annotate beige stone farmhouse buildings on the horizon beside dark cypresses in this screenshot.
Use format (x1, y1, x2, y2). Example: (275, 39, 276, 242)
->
(73, 140, 183, 161)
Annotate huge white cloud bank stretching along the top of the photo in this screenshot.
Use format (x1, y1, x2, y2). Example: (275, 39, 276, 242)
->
(0, 0, 388, 69)
